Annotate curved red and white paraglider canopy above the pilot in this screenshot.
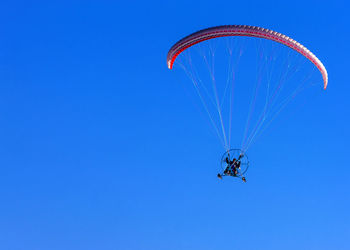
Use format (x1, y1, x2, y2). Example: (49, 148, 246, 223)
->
(167, 25, 328, 89)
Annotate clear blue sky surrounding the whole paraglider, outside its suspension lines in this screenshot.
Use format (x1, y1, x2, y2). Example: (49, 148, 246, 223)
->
(0, 1, 350, 250)
